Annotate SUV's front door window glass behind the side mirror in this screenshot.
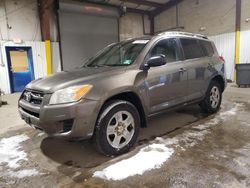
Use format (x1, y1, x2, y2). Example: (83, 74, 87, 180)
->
(150, 39, 181, 63)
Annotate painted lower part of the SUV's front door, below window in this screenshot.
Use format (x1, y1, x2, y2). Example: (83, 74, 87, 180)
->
(145, 62, 187, 113)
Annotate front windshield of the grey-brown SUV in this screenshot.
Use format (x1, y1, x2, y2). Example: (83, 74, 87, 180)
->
(84, 40, 149, 67)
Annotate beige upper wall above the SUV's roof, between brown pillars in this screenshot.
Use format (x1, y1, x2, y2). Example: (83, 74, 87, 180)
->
(155, 0, 236, 36)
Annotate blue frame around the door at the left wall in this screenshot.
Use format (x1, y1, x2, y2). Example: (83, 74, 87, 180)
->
(5, 46, 35, 93)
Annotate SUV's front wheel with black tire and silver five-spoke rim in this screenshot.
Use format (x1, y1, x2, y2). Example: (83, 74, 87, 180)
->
(93, 100, 140, 156)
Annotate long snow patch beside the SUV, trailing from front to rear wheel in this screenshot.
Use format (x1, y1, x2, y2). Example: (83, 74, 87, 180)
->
(93, 103, 242, 180)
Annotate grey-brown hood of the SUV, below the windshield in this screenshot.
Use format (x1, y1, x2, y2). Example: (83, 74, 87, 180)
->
(26, 67, 126, 93)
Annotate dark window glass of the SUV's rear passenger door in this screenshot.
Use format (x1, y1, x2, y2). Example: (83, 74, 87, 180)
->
(180, 39, 204, 59)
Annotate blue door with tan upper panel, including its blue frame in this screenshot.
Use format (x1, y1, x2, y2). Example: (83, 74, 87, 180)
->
(6, 47, 34, 93)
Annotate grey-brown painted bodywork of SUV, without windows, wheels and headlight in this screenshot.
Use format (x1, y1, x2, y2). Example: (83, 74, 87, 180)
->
(19, 32, 226, 139)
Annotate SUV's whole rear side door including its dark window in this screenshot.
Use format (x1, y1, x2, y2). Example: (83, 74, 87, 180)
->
(180, 38, 211, 101)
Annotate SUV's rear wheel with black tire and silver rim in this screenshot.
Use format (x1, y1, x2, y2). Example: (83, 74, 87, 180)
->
(200, 81, 222, 114)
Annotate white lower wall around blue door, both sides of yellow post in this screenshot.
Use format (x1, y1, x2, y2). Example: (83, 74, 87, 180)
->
(0, 41, 60, 93)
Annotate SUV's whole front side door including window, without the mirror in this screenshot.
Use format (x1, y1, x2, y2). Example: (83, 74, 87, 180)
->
(145, 38, 187, 113)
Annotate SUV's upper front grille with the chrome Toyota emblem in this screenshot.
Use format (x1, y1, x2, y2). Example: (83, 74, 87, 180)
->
(22, 90, 44, 105)
